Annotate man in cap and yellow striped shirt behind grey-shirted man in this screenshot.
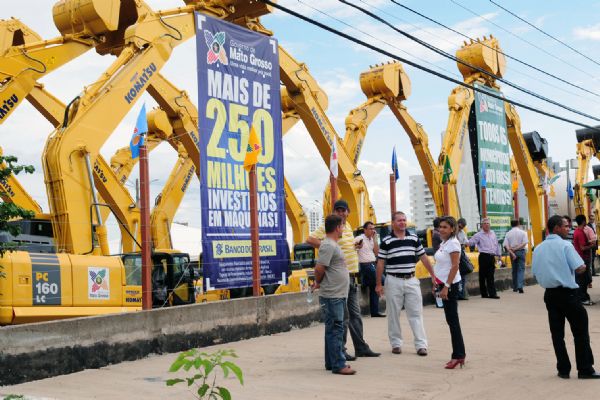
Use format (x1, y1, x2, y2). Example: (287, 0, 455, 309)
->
(306, 200, 381, 361)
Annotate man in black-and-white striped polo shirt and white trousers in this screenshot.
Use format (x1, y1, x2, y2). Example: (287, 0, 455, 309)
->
(375, 211, 435, 356)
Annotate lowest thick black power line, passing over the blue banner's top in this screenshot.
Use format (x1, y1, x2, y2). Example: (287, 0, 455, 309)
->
(259, 0, 600, 131)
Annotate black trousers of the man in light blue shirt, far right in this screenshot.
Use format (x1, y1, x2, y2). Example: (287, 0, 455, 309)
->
(544, 288, 594, 374)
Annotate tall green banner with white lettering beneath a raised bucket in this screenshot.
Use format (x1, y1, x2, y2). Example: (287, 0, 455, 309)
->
(474, 84, 514, 240)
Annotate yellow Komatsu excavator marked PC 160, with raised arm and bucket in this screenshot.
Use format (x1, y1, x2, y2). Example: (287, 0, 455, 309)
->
(0, 0, 269, 324)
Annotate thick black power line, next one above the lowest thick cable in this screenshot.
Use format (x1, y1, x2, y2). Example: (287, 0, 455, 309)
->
(339, 0, 600, 121)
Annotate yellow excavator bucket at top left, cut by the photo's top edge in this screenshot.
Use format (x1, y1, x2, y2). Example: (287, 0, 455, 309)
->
(52, 0, 121, 36)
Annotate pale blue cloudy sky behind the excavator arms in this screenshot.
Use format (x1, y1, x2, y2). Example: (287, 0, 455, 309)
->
(0, 0, 600, 247)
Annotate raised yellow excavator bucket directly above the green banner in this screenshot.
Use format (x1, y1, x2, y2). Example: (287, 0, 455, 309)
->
(456, 35, 506, 79)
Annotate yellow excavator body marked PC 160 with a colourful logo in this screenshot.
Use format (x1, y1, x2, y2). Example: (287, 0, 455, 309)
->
(0, 251, 142, 325)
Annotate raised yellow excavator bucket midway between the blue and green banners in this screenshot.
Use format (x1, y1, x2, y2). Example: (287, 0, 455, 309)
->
(360, 62, 410, 100)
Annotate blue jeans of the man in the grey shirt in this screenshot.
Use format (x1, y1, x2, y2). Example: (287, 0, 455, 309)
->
(319, 297, 346, 372)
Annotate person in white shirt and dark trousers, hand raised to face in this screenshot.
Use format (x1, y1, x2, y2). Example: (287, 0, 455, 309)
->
(354, 221, 385, 318)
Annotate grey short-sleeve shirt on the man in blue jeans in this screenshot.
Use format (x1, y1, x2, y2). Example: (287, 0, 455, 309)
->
(317, 237, 350, 299)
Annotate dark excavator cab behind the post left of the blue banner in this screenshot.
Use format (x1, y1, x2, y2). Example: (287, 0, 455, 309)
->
(122, 252, 195, 308)
